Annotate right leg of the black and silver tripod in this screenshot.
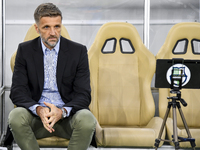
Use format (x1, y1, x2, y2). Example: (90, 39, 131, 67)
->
(177, 104, 196, 149)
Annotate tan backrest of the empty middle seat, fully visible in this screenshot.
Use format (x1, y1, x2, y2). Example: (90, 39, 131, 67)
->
(88, 22, 155, 126)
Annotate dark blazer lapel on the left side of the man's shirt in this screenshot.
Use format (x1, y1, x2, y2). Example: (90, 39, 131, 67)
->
(33, 38, 44, 90)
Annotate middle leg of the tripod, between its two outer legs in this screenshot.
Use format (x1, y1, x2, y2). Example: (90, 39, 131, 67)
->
(173, 103, 179, 150)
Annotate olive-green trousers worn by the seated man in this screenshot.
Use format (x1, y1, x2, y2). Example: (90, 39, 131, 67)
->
(8, 107, 96, 150)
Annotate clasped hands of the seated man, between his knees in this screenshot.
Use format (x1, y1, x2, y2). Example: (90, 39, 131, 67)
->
(36, 102, 62, 133)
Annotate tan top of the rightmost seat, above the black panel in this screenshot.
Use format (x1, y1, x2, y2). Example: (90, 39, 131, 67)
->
(156, 22, 200, 59)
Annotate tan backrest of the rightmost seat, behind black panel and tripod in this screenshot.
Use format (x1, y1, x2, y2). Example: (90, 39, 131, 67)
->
(156, 22, 200, 127)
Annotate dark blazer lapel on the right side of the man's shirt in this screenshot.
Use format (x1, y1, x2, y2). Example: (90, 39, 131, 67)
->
(56, 37, 69, 90)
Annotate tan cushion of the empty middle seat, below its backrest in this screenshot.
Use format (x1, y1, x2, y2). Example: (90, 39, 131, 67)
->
(102, 117, 165, 147)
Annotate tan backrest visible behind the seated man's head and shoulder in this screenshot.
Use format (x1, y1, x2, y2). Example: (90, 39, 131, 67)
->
(10, 24, 70, 72)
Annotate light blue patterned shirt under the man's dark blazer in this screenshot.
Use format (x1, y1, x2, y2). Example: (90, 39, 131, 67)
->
(29, 40, 72, 116)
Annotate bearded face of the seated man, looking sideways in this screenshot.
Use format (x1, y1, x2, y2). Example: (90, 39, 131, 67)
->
(35, 16, 61, 50)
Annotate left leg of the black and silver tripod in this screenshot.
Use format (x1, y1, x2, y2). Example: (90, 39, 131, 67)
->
(154, 102, 171, 150)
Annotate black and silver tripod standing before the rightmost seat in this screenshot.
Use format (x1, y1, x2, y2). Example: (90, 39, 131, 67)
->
(154, 89, 196, 150)
